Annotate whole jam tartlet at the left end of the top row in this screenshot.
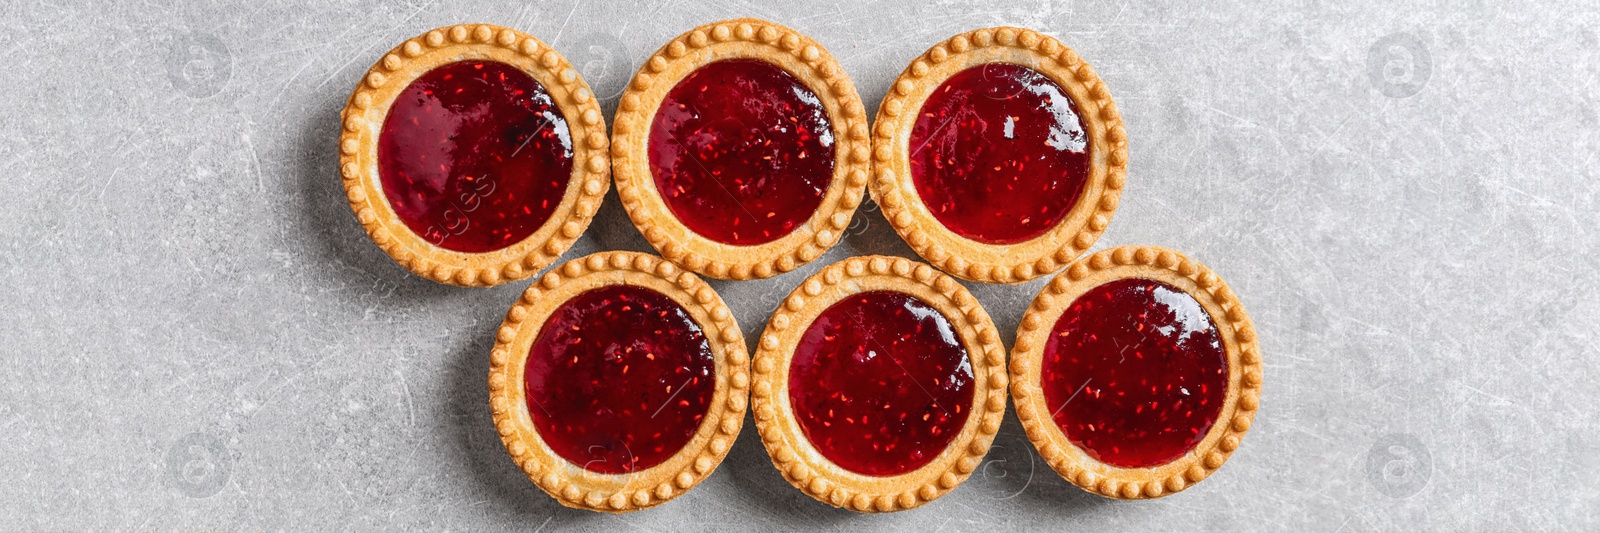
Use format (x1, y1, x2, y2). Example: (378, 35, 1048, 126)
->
(339, 24, 611, 287)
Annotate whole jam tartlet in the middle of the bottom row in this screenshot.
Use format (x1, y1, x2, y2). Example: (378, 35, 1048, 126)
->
(750, 256, 1006, 512)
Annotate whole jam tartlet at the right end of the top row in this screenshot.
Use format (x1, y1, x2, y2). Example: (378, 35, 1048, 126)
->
(870, 27, 1128, 283)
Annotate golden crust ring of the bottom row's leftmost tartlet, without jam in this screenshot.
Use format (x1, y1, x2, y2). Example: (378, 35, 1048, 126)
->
(490, 251, 750, 512)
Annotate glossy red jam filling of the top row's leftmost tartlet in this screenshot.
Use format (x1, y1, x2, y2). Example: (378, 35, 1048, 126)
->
(378, 61, 573, 253)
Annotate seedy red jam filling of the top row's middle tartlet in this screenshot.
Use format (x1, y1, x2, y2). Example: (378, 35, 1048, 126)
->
(650, 59, 834, 245)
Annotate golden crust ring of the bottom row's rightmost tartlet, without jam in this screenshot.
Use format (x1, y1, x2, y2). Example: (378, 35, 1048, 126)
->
(1011, 246, 1261, 499)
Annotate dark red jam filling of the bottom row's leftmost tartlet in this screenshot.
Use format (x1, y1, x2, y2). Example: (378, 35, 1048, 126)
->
(523, 285, 717, 474)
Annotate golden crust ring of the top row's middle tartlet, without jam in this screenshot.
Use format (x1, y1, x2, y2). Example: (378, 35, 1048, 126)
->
(611, 19, 870, 280)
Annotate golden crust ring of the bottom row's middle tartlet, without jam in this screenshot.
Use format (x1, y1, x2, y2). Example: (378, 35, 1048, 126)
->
(750, 256, 1008, 512)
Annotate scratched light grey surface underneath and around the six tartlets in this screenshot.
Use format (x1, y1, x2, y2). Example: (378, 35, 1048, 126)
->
(0, 0, 1600, 531)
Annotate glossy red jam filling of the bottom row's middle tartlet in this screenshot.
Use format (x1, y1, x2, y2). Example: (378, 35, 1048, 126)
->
(789, 291, 973, 475)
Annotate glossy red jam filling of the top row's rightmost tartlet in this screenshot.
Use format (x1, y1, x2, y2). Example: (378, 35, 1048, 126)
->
(907, 62, 1090, 245)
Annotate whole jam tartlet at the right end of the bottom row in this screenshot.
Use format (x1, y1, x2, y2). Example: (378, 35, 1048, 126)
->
(1011, 246, 1261, 499)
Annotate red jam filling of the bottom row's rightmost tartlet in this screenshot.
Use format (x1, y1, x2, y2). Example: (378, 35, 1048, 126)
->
(1040, 279, 1227, 467)
